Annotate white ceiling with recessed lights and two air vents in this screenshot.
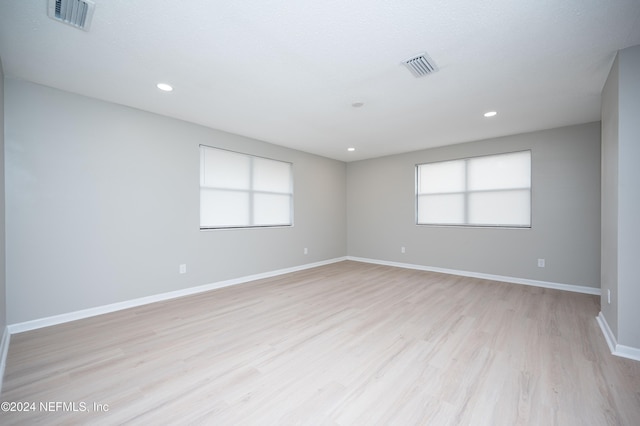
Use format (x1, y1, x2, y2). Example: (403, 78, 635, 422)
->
(0, 0, 640, 161)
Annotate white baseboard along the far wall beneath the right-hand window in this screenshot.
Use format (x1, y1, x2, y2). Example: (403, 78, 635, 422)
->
(347, 256, 601, 296)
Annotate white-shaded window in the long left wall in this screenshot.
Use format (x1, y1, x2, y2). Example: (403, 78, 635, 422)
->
(200, 145, 293, 229)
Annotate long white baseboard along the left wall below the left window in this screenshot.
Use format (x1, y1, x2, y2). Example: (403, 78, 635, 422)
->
(7, 257, 347, 334)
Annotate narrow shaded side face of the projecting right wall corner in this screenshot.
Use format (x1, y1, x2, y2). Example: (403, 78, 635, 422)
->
(600, 57, 619, 336)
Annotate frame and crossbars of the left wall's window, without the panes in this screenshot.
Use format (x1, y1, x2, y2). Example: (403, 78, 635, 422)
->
(198, 144, 294, 231)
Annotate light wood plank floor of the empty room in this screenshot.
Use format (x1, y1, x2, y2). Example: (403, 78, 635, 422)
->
(0, 262, 640, 426)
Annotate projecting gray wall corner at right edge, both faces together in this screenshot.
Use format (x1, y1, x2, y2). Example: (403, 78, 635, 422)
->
(601, 46, 640, 350)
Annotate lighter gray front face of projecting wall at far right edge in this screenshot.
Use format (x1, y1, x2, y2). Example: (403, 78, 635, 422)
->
(618, 46, 640, 349)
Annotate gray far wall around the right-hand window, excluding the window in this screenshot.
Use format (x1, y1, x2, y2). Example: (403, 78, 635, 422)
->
(347, 123, 600, 288)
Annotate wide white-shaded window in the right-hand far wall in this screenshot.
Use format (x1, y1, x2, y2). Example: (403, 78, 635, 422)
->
(416, 151, 531, 228)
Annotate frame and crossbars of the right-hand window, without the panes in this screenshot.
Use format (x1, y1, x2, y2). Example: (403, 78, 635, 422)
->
(414, 149, 533, 229)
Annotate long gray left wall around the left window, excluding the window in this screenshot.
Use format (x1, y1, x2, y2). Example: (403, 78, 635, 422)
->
(5, 78, 346, 324)
